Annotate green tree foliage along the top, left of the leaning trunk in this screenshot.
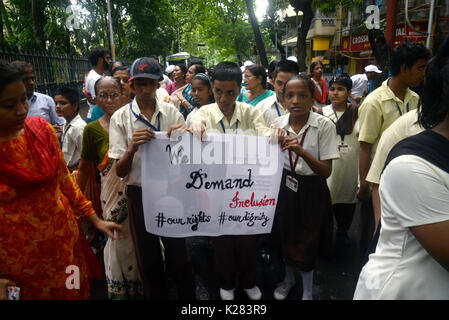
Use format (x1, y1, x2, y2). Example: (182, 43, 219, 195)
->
(0, 0, 267, 63)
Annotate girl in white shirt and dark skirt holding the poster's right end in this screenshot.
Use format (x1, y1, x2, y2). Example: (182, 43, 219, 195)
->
(272, 75, 339, 300)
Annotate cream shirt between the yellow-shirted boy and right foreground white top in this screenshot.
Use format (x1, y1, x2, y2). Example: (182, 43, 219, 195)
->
(366, 109, 424, 184)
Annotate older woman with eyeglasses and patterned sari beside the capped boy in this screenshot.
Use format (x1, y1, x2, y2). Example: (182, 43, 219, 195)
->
(78, 77, 143, 299)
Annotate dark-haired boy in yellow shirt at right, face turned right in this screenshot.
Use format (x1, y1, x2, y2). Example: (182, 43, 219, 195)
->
(357, 41, 430, 262)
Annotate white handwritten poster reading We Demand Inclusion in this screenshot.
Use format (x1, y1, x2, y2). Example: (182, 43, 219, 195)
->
(141, 132, 284, 238)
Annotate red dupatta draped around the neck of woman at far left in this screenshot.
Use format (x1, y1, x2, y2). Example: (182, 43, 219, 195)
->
(0, 117, 59, 188)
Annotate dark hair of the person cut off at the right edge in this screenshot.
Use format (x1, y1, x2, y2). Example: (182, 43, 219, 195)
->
(419, 37, 449, 129)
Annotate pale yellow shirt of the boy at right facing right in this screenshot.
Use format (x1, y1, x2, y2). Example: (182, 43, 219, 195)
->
(359, 79, 419, 159)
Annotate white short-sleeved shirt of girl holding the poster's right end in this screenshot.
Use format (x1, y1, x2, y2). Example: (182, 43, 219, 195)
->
(271, 111, 340, 176)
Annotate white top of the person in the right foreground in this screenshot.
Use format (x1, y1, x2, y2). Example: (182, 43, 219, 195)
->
(354, 155, 449, 299)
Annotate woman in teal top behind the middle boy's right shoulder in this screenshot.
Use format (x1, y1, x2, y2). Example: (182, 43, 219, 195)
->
(237, 64, 274, 106)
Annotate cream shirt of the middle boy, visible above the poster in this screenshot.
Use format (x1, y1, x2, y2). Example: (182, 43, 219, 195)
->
(190, 101, 270, 136)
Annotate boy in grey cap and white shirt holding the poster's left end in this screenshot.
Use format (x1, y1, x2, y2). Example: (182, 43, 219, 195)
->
(109, 58, 195, 299)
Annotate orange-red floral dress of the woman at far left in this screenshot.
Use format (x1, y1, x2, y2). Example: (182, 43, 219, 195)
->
(0, 124, 99, 300)
